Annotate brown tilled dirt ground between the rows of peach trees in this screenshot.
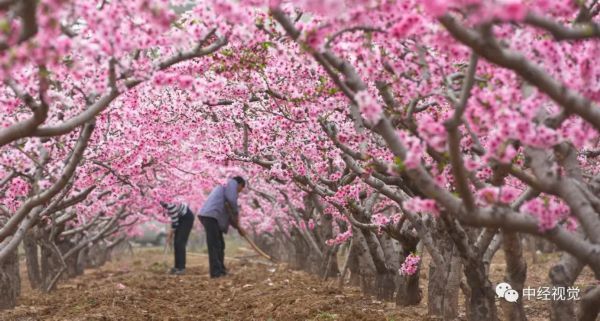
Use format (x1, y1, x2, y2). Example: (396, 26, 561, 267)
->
(0, 244, 595, 321)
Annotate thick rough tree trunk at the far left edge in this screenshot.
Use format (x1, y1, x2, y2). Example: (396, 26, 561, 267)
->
(0, 238, 21, 310)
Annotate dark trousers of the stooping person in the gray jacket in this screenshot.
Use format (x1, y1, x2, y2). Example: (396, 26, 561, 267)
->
(200, 216, 226, 278)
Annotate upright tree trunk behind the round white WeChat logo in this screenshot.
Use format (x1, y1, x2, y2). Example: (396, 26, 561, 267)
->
(500, 232, 527, 321)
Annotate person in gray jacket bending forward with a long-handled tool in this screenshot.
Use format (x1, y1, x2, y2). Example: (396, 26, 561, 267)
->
(198, 176, 246, 278)
